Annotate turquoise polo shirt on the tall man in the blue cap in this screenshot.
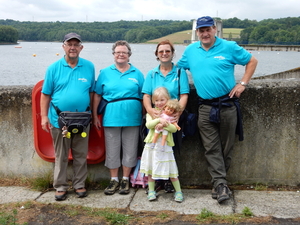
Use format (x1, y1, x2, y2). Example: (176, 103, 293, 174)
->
(177, 37, 252, 99)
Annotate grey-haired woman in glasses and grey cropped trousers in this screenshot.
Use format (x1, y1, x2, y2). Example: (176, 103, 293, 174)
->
(93, 41, 144, 195)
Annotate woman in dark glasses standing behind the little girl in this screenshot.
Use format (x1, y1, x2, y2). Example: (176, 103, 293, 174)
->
(142, 40, 190, 195)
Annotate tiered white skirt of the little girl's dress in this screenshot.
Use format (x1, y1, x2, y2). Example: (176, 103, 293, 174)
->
(140, 138, 178, 180)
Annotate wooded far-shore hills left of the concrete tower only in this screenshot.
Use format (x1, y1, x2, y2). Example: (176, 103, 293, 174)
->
(0, 20, 192, 43)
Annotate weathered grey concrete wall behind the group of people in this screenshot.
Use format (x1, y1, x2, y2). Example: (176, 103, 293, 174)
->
(0, 79, 300, 185)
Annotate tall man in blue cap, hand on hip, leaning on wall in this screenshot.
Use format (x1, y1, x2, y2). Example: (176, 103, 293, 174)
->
(177, 16, 257, 203)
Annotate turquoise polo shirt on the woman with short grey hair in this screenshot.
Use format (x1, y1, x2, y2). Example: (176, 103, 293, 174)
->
(94, 64, 144, 127)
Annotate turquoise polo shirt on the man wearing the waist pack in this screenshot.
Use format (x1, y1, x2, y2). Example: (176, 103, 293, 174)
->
(42, 57, 95, 128)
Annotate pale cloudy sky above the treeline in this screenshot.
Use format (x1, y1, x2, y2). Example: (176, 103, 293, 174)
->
(0, 0, 300, 22)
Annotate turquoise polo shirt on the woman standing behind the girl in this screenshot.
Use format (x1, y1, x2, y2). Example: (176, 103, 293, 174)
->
(142, 62, 190, 100)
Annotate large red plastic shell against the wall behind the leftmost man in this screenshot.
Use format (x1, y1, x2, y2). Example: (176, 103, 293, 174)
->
(32, 80, 105, 164)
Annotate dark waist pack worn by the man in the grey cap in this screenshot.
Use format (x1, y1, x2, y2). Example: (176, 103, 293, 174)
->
(52, 103, 92, 138)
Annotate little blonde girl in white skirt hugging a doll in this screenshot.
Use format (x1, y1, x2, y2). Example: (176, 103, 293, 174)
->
(140, 87, 183, 202)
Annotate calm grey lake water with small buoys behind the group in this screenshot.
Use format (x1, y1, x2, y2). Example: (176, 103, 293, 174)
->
(0, 42, 300, 85)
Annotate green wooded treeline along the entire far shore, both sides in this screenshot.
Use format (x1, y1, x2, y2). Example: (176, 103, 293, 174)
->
(0, 17, 300, 45)
